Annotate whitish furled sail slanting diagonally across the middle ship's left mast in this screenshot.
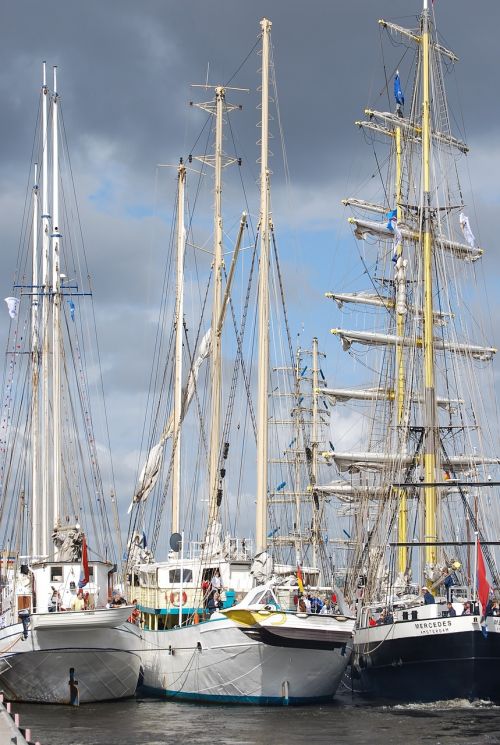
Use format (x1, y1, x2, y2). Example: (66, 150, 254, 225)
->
(128, 329, 212, 513)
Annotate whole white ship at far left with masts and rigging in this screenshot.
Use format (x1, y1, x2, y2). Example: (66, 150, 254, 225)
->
(0, 63, 141, 704)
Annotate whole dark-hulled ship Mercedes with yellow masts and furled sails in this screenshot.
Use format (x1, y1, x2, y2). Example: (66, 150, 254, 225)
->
(323, 0, 500, 701)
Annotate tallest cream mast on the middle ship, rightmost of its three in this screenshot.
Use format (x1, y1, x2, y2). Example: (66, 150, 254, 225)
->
(255, 18, 272, 553)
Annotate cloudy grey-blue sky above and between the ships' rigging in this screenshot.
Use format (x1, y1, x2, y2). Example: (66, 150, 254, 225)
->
(0, 0, 500, 548)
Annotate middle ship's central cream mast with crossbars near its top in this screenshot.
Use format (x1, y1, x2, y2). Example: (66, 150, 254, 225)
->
(208, 86, 226, 534)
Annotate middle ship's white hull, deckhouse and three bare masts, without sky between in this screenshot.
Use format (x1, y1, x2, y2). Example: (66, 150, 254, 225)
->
(129, 19, 354, 705)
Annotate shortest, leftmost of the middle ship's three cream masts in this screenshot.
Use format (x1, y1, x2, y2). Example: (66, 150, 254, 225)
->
(172, 163, 186, 536)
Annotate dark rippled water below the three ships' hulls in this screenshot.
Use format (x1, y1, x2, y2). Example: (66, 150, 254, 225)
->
(14, 695, 500, 745)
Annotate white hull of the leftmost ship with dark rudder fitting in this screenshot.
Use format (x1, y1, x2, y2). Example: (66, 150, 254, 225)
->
(0, 614, 141, 704)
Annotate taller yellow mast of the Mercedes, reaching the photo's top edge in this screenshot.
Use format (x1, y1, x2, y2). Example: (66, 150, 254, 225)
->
(422, 0, 437, 565)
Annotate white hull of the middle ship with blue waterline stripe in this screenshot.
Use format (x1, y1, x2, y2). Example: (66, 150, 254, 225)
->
(142, 617, 350, 705)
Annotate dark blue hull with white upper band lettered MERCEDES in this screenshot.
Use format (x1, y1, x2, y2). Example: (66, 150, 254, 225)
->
(352, 616, 500, 702)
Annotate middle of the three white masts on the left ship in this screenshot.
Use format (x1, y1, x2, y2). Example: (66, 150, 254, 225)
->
(40, 62, 50, 556)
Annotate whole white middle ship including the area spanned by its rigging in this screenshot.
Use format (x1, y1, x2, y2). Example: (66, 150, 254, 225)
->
(128, 19, 354, 705)
